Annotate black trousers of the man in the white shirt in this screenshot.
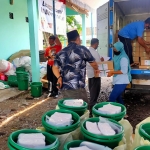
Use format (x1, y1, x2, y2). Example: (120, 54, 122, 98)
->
(88, 77, 101, 113)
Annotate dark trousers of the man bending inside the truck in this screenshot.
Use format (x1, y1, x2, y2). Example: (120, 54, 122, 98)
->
(118, 35, 134, 64)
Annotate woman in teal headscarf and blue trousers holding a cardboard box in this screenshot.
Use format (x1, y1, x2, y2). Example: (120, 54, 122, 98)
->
(108, 42, 131, 104)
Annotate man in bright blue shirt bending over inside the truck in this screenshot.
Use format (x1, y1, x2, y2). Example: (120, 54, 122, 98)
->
(118, 18, 150, 66)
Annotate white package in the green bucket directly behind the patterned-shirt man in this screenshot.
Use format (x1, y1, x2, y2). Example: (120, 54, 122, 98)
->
(63, 99, 83, 107)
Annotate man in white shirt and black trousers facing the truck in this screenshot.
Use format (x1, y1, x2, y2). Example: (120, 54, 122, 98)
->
(86, 38, 104, 116)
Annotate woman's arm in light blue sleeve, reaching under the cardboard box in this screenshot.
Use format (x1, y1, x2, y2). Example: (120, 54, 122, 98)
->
(108, 58, 129, 77)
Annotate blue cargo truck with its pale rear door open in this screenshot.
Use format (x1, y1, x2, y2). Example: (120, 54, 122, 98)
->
(97, 0, 150, 90)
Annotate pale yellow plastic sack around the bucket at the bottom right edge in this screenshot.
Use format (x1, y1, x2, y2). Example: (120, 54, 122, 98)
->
(131, 117, 150, 150)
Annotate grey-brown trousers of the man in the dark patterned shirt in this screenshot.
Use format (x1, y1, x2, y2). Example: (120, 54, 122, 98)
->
(61, 88, 88, 103)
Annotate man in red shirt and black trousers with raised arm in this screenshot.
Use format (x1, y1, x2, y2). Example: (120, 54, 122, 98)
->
(45, 36, 62, 98)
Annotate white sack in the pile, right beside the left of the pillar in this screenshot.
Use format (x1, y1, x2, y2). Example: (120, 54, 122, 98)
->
(19, 56, 31, 67)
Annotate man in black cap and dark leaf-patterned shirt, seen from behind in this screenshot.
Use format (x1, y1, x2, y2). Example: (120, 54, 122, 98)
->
(53, 30, 98, 103)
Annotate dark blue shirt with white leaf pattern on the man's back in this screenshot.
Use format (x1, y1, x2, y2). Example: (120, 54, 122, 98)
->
(54, 42, 95, 90)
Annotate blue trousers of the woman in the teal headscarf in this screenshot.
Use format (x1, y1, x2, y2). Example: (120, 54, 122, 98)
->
(109, 84, 127, 104)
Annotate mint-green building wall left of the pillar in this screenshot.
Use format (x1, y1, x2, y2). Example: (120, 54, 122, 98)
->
(0, 0, 30, 59)
